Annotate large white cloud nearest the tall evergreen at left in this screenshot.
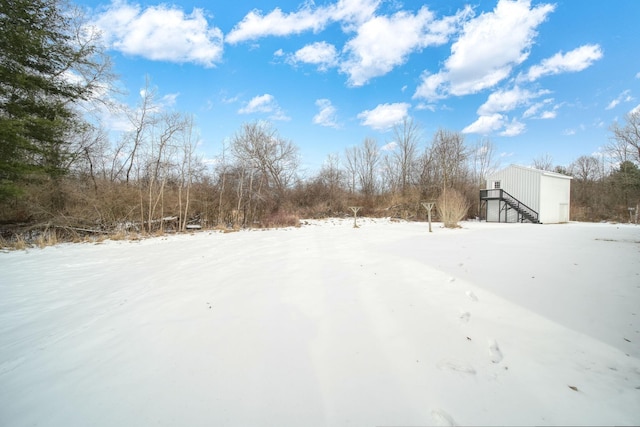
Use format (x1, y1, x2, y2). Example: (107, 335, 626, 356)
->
(92, 1, 223, 67)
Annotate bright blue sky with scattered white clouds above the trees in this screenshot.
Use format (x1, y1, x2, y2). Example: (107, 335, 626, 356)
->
(76, 0, 640, 174)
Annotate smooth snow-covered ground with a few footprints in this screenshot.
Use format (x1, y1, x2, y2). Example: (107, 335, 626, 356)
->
(0, 219, 640, 426)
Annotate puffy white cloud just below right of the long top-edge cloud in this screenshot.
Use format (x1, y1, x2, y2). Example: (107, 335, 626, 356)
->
(340, 6, 471, 86)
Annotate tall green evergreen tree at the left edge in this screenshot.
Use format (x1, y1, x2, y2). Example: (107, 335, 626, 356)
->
(0, 0, 96, 200)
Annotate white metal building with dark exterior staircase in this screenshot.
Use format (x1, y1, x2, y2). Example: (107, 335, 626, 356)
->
(480, 165, 572, 224)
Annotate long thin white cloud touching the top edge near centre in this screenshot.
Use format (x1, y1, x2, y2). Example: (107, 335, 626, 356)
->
(226, 0, 380, 44)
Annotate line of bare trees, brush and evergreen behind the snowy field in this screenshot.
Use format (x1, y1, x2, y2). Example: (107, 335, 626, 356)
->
(0, 0, 640, 244)
